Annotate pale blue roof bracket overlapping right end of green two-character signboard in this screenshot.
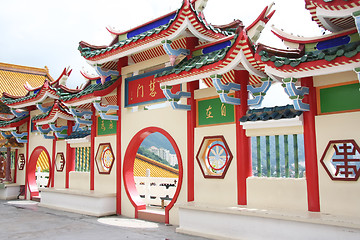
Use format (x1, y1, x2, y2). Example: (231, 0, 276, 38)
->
(210, 74, 241, 105)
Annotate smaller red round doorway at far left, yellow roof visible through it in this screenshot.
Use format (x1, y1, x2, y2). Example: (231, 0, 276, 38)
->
(27, 146, 51, 199)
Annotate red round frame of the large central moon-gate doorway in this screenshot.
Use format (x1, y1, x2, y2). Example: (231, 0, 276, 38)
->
(123, 127, 183, 223)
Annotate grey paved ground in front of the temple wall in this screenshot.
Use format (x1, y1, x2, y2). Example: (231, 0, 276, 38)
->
(0, 200, 208, 240)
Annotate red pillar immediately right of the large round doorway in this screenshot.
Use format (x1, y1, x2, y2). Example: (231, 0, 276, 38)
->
(186, 37, 199, 202)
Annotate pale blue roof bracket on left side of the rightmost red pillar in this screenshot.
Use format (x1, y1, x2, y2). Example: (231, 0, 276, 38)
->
(282, 77, 310, 111)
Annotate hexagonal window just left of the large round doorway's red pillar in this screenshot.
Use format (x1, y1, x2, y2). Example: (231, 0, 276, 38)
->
(95, 143, 115, 174)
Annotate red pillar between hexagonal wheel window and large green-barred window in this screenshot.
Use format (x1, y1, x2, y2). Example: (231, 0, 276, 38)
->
(235, 71, 252, 205)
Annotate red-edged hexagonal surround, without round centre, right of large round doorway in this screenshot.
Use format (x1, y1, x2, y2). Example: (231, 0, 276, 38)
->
(196, 136, 233, 179)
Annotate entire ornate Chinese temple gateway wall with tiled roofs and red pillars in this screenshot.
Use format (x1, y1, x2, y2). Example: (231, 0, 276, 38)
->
(0, 0, 360, 239)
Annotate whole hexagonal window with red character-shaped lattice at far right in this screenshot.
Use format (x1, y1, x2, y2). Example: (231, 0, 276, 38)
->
(320, 140, 360, 181)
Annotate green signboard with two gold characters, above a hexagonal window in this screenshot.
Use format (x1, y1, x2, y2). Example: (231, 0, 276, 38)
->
(196, 97, 235, 126)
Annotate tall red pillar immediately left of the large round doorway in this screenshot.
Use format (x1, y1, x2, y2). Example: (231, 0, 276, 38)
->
(116, 57, 128, 215)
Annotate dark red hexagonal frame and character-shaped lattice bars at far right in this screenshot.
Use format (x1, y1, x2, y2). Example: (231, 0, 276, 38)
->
(320, 139, 360, 181)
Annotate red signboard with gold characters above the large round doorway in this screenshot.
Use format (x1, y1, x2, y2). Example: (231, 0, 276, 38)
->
(125, 68, 181, 107)
